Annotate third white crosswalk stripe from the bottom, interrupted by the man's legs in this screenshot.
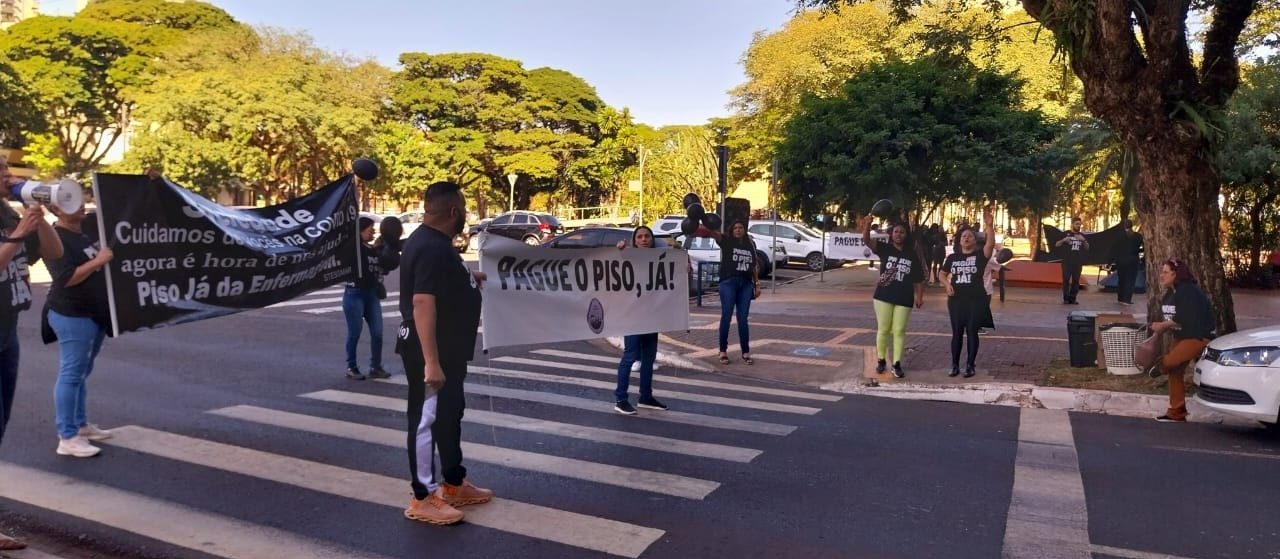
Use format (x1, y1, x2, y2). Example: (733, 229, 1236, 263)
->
(209, 405, 719, 500)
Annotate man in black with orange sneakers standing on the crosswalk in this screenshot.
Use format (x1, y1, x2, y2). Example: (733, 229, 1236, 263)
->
(396, 183, 493, 524)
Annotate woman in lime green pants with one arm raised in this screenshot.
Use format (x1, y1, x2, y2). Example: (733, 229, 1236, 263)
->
(863, 216, 924, 379)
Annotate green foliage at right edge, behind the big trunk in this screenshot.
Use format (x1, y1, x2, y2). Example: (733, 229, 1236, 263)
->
(1217, 58, 1280, 272)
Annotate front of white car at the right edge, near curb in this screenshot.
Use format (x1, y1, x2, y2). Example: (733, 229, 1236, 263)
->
(1196, 325, 1280, 427)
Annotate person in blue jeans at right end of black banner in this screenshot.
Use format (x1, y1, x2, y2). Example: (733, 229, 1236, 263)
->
(342, 217, 399, 380)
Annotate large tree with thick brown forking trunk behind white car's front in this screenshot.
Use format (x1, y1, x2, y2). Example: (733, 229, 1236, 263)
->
(799, 0, 1257, 333)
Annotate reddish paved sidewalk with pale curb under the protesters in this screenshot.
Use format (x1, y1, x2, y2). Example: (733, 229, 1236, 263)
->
(611, 265, 1280, 422)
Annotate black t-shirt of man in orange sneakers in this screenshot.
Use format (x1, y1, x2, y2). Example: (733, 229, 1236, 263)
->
(399, 226, 480, 361)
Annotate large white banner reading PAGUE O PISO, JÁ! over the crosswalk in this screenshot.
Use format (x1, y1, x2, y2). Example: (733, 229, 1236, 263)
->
(480, 235, 689, 349)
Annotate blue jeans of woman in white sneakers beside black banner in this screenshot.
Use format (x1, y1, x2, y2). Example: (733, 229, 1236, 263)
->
(49, 311, 106, 439)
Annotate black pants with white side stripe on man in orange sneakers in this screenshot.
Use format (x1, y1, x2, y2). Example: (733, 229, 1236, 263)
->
(396, 321, 467, 499)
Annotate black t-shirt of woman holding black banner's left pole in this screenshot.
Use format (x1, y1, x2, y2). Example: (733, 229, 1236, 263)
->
(45, 226, 108, 321)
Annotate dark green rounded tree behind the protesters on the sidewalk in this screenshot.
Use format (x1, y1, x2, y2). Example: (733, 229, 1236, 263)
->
(778, 56, 1064, 222)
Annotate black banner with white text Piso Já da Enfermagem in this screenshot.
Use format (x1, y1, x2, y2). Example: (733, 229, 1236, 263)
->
(93, 174, 360, 334)
